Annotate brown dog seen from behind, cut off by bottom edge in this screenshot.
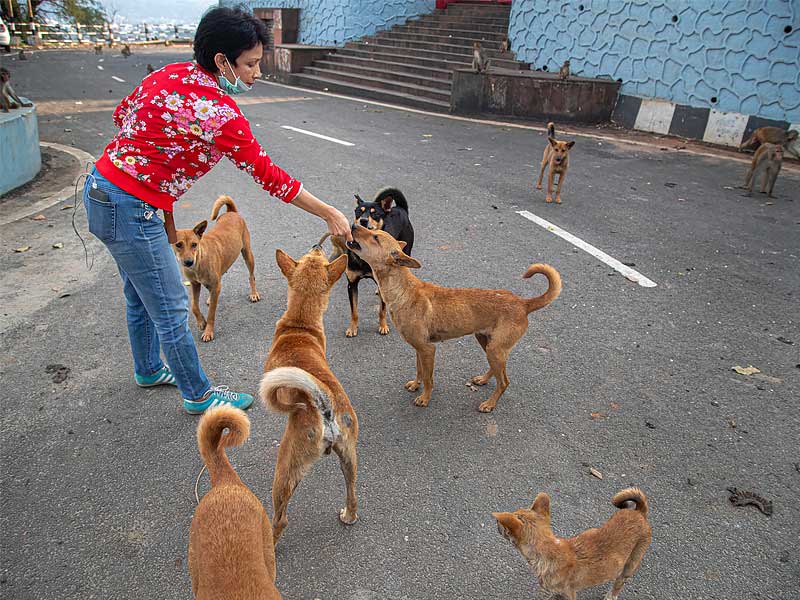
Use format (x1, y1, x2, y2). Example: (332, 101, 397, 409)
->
(189, 406, 281, 600)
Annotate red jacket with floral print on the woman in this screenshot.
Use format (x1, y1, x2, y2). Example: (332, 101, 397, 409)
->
(96, 63, 303, 211)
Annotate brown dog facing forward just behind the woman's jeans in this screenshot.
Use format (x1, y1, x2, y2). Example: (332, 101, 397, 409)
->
(173, 196, 261, 342)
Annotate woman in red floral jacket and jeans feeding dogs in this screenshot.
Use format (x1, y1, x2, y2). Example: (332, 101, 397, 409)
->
(83, 8, 352, 414)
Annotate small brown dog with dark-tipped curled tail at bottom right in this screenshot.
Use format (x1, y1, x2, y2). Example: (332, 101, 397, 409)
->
(492, 488, 650, 600)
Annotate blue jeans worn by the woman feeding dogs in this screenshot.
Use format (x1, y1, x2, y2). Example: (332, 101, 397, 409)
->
(83, 169, 211, 400)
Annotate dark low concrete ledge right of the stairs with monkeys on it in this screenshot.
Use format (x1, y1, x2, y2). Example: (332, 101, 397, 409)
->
(450, 69, 620, 123)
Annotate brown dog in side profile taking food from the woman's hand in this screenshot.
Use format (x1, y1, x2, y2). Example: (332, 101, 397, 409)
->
(348, 225, 561, 412)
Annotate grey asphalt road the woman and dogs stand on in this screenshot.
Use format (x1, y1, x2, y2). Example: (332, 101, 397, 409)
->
(0, 49, 800, 600)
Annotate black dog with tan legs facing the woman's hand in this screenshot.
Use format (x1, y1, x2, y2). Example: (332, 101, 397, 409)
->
(331, 188, 414, 337)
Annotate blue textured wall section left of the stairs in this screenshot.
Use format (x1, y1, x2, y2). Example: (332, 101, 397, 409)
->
(220, 0, 435, 46)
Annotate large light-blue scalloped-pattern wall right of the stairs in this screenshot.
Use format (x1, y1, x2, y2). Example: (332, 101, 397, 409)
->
(509, 0, 800, 123)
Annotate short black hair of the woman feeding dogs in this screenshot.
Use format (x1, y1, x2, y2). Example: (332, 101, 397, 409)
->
(194, 7, 268, 73)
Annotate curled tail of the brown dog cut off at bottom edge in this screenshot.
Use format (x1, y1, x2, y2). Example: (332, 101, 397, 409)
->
(197, 406, 250, 487)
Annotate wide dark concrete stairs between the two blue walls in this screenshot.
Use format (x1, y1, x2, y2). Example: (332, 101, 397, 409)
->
(292, 2, 530, 112)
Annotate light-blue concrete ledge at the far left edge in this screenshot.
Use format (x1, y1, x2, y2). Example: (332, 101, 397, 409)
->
(0, 98, 42, 195)
